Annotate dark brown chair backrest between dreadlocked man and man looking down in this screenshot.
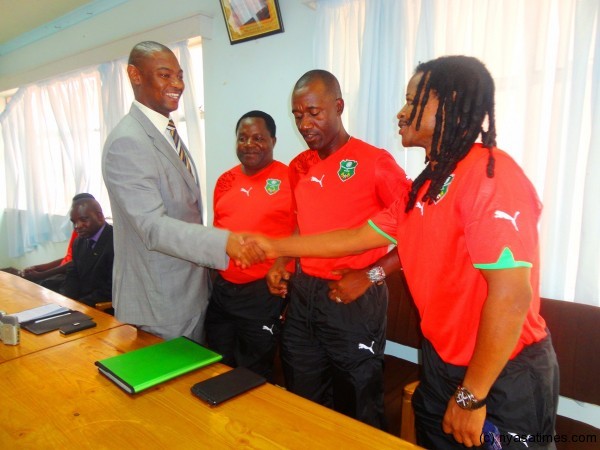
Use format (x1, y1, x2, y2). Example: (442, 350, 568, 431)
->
(385, 273, 421, 348)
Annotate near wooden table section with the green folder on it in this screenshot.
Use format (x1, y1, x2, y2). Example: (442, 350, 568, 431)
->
(0, 272, 417, 450)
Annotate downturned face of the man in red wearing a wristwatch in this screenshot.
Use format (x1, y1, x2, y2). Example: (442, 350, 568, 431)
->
(292, 80, 348, 156)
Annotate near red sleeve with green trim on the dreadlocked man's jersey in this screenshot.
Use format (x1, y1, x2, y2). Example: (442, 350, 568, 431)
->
(460, 155, 541, 269)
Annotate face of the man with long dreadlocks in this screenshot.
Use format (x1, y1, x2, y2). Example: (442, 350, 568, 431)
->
(396, 72, 439, 159)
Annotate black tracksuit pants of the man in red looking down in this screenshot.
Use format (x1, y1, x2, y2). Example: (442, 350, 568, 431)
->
(281, 273, 388, 429)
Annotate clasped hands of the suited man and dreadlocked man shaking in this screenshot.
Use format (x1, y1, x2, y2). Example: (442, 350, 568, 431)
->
(226, 233, 282, 269)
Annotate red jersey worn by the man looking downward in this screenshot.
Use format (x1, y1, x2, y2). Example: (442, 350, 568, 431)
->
(290, 138, 410, 279)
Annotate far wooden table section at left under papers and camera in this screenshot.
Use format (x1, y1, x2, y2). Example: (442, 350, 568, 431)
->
(0, 271, 122, 363)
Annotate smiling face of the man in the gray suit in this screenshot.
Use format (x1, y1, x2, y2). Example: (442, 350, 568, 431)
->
(127, 51, 185, 117)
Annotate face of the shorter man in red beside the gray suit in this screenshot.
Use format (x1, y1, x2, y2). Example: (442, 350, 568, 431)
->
(236, 117, 277, 176)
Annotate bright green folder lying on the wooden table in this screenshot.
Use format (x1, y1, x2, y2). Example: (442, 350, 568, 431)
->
(95, 337, 223, 394)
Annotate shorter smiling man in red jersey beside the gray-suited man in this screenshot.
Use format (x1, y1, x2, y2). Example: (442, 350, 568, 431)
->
(206, 111, 295, 379)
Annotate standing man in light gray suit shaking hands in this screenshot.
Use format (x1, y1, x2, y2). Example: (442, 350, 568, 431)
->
(102, 41, 253, 341)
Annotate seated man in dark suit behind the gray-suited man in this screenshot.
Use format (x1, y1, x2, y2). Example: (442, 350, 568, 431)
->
(60, 198, 114, 306)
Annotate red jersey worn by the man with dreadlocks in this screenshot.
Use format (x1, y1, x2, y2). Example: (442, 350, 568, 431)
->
(371, 144, 546, 366)
